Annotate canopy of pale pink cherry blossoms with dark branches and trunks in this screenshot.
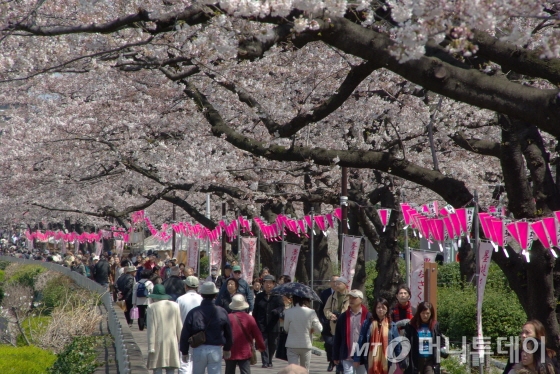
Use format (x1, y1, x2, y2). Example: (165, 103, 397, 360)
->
(0, 0, 560, 344)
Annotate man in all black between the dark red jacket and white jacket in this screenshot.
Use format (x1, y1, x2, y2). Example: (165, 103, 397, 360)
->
(253, 275, 284, 368)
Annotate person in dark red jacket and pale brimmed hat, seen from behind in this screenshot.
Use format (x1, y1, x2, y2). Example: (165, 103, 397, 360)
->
(225, 294, 266, 374)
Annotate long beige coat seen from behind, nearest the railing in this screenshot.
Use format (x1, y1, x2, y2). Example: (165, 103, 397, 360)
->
(146, 300, 183, 370)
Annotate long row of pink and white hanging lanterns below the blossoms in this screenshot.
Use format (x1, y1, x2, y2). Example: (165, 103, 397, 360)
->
(21, 201, 560, 261)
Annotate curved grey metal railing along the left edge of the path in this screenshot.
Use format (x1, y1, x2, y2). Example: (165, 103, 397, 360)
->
(0, 256, 148, 374)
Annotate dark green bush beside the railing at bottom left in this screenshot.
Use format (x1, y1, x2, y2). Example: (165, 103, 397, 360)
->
(49, 336, 106, 374)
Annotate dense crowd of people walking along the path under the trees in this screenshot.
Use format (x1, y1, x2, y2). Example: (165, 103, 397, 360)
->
(2, 250, 560, 374)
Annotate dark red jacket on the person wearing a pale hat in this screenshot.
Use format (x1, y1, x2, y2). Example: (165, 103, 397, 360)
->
(228, 312, 266, 360)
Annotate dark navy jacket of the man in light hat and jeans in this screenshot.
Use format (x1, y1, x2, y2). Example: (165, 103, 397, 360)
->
(179, 299, 233, 355)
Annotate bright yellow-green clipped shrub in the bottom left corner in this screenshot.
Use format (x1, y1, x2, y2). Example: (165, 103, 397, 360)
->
(0, 345, 55, 374)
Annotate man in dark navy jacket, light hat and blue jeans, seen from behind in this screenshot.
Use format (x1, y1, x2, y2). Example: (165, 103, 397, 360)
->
(180, 282, 233, 374)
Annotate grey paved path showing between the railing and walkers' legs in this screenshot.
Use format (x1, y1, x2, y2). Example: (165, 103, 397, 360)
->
(130, 321, 334, 374)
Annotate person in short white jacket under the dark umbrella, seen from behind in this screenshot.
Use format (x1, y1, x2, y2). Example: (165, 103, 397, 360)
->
(284, 295, 323, 370)
